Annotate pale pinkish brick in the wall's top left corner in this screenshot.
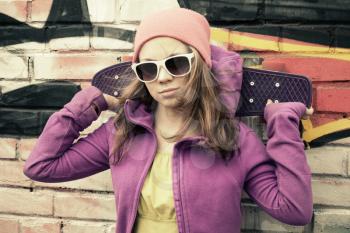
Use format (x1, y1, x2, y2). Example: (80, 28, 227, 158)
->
(0, 0, 27, 22)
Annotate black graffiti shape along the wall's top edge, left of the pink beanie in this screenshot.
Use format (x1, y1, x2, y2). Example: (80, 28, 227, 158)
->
(0, 0, 135, 46)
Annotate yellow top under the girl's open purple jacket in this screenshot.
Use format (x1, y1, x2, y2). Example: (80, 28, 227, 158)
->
(133, 152, 179, 233)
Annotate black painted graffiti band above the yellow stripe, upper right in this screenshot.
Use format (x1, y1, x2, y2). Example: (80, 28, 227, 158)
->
(178, 0, 350, 48)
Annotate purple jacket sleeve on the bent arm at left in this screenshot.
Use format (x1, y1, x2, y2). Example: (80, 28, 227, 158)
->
(23, 86, 111, 183)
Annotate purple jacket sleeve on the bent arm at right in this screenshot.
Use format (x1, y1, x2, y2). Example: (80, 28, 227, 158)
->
(243, 102, 313, 225)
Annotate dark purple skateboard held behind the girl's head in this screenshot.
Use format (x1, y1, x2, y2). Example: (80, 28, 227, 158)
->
(91, 62, 312, 117)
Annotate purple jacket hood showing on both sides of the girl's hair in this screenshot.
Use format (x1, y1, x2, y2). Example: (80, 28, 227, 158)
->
(124, 45, 243, 128)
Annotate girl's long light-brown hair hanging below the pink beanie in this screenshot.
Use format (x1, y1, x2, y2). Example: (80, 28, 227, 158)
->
(112, 46, 239, 164)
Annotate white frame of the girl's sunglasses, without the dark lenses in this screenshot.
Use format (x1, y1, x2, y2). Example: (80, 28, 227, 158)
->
(131, 52, 194, 83)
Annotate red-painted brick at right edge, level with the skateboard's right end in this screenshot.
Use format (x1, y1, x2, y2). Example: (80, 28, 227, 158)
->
(314, 82, 350, 113)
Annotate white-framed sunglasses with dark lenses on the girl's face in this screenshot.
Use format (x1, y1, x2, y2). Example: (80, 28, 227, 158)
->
(131, 52, 194, 82)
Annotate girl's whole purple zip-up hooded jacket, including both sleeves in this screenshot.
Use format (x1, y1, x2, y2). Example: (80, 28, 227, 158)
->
(23, 46, 313, 233)
